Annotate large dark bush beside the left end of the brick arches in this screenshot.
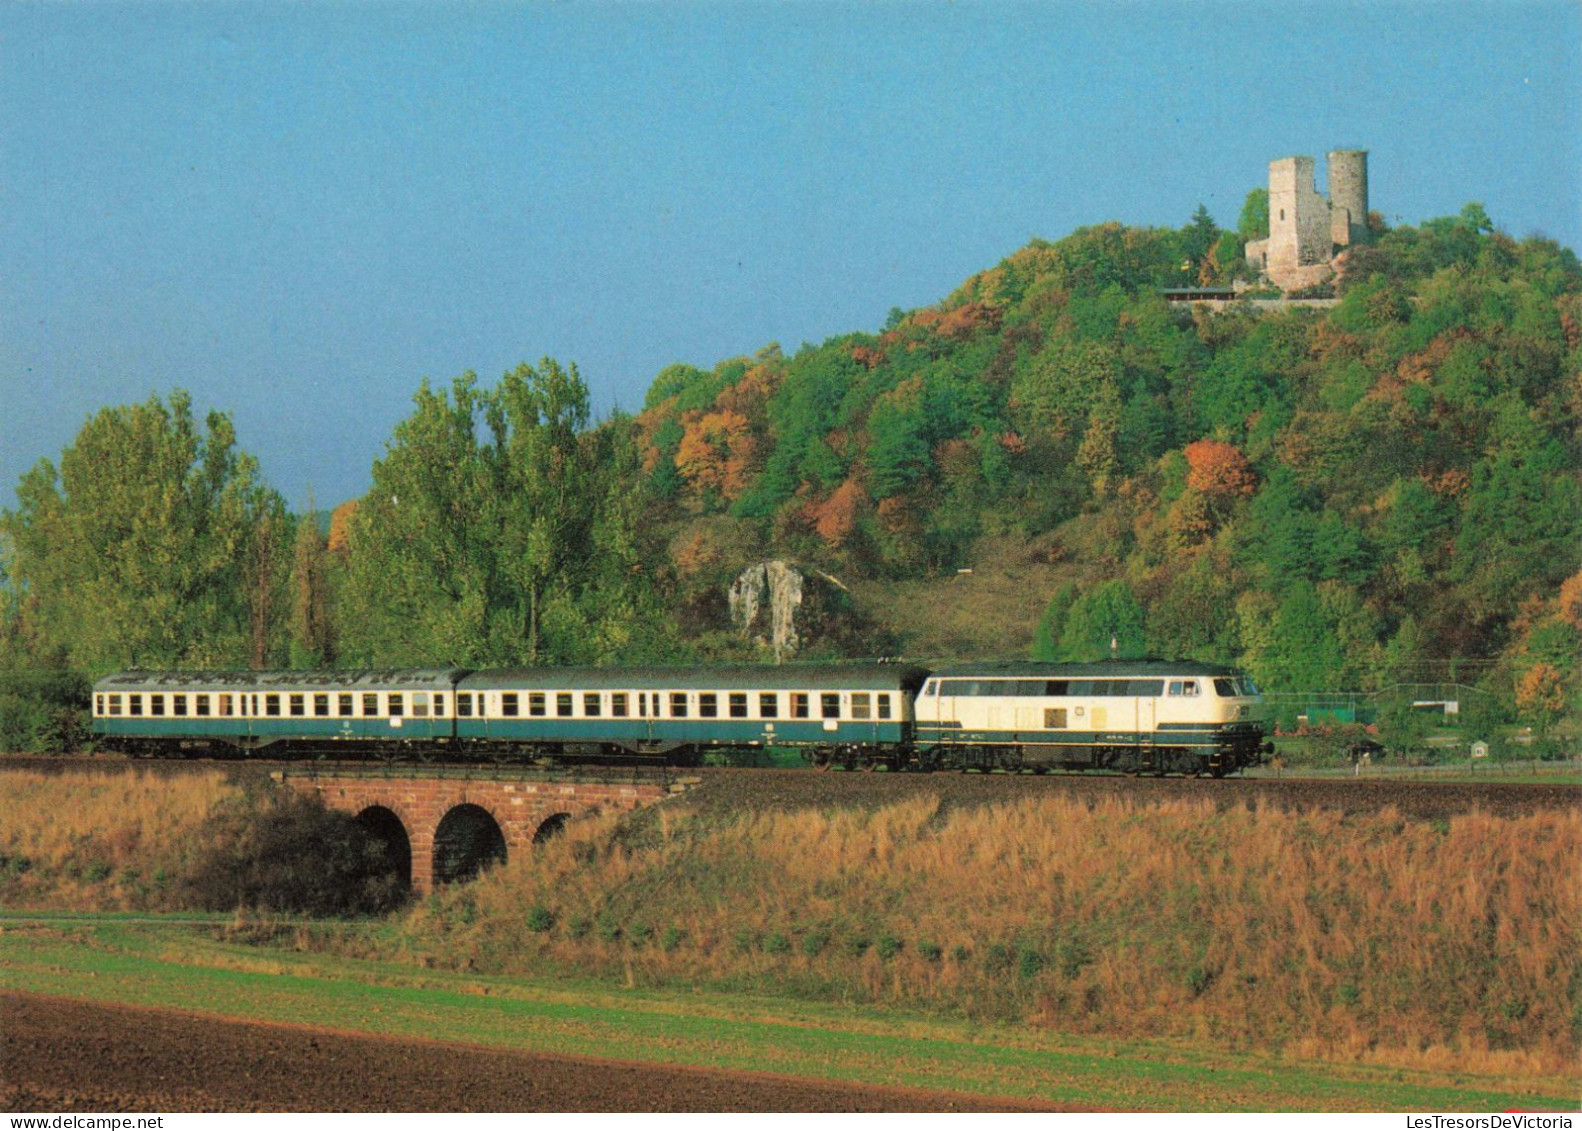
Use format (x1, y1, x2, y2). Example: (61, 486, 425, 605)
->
(179, 789, 407, 916)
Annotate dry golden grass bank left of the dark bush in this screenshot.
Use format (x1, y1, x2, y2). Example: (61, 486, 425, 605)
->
(0, 769, 237, 910)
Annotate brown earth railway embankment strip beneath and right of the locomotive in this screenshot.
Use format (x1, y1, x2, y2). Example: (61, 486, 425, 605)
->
(683, 769, 1582, 821)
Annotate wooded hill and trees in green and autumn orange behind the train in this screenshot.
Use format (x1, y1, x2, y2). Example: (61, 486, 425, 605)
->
(0, 206, 1582, 742)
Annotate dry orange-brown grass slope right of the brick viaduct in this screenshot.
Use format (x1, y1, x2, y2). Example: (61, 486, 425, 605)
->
(410, 799, 1582, 1074)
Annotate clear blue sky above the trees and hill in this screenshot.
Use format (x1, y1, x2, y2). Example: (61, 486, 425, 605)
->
(0, 0, 1582, 506)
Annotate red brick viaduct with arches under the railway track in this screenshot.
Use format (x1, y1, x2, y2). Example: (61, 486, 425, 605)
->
(277, 769, 685, 897)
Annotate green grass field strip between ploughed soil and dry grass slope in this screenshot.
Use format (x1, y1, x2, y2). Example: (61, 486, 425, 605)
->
(0, 916, 1577, 1110)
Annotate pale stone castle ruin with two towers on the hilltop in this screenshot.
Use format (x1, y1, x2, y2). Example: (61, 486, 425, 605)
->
(1247, 149, 1368, 291)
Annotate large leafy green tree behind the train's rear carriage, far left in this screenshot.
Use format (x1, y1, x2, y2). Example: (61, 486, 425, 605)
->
(0, 391, 288, 672)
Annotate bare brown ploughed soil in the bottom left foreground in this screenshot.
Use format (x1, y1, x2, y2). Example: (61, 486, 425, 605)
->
(0, 993, 1054, 1114)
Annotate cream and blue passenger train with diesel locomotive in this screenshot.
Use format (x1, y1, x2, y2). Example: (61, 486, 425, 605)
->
(92, 660, 1274, 777)
